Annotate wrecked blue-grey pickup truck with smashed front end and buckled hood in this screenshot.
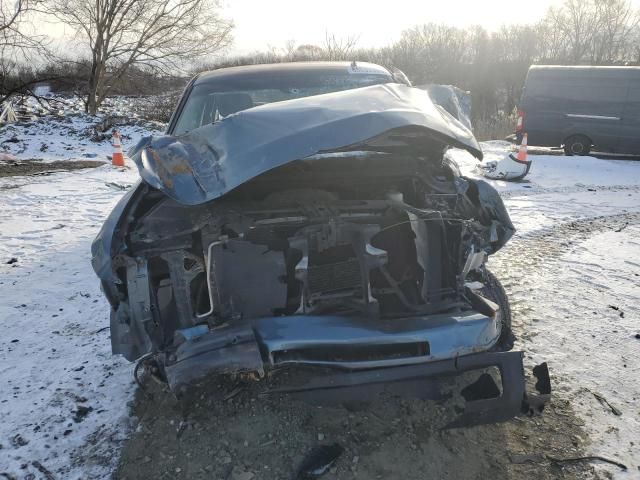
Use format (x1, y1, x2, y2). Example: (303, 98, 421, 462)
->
(92, 63, 550, 426)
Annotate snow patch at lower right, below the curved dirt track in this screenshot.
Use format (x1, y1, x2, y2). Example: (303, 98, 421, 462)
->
(528, 224, 640, 478)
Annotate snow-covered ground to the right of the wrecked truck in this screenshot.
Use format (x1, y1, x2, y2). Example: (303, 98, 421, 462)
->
(449, 146, 640, 478)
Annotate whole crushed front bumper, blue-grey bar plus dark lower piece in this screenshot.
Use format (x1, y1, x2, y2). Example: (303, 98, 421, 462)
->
(162, 313, 551, 428)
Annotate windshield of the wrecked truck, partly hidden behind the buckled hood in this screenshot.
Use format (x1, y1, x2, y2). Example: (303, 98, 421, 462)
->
(171, 72, 392, 135)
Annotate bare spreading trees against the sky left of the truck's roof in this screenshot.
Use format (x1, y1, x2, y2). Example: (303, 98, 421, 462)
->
(0, 0, 233, 114)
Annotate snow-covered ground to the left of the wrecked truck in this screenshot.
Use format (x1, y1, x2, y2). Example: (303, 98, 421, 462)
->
(0, 111, 159, 478)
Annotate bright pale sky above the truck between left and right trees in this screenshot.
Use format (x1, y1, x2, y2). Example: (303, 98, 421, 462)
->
(223, 0, 564, 54)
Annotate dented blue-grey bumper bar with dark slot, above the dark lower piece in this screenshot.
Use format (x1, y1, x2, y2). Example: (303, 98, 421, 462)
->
(163, 311, 500, 392)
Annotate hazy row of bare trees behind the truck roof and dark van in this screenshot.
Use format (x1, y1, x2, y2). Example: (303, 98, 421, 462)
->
(211, 0, 640, 122)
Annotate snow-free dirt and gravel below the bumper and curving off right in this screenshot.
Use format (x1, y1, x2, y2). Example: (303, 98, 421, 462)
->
(115, 214, 640, 480)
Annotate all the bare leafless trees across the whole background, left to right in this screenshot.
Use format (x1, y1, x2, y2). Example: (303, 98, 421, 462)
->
(0, 0, 640, 121)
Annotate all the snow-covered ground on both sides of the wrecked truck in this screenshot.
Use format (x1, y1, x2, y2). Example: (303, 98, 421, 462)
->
(0, 117, 640, 478)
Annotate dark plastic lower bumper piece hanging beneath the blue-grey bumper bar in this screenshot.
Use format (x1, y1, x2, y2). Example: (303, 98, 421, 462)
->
(266, 352, 551, 428)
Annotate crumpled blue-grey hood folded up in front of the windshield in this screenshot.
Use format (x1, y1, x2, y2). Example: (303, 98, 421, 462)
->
(129, 84, 482, 205)
